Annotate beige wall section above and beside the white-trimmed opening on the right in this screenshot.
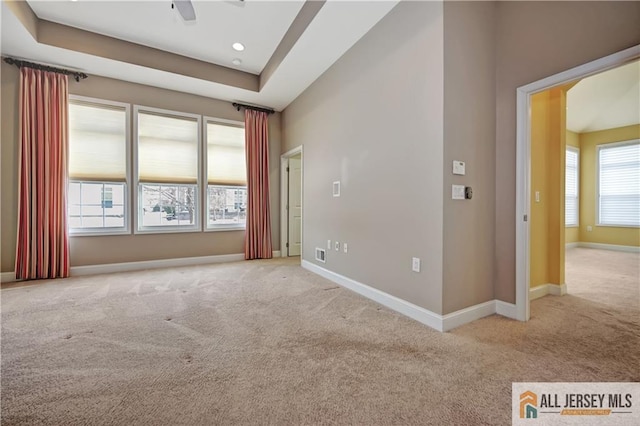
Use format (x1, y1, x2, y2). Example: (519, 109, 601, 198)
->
(495, 1, 640, 303)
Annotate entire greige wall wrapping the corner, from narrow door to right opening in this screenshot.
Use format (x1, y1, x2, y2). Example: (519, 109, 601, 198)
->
(283, 2, 640, 314)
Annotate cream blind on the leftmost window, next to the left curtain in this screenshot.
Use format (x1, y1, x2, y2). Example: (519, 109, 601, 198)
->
(69, 99, 127, 182)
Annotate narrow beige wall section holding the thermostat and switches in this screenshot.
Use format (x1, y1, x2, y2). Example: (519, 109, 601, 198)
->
(443, 2, 495, 314)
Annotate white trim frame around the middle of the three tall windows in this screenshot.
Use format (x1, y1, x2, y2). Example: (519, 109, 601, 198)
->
(131, 105, 204, 235)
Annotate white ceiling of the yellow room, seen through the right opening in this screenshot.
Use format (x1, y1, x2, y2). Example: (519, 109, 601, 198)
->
(567, 61, 640, 133)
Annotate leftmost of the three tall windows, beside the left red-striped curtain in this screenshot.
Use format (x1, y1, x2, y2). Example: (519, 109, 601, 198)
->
(68, 96, 129, 235)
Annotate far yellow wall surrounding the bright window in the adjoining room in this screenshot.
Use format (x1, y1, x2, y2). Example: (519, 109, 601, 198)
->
(580, 125, 640, 247)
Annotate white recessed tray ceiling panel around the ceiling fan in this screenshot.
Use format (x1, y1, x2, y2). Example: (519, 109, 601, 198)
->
(27, 0, 304, 74)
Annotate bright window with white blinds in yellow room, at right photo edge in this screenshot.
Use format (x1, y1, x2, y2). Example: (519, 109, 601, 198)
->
(598, 141, 640, 226)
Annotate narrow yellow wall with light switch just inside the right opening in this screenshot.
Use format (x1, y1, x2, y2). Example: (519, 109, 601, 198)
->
(529, 88, 566, 287)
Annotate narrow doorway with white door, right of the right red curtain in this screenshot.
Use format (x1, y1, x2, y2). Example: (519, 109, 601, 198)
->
(280, 146, 303, 257)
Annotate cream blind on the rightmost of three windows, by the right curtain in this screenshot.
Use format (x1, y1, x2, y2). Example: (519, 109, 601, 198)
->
(207, 122, 247, 186)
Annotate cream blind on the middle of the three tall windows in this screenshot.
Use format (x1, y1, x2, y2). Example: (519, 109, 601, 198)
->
(137, 111, 199, 184)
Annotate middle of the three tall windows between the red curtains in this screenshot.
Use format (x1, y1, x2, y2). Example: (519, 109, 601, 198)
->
(135, 107, 200, 232)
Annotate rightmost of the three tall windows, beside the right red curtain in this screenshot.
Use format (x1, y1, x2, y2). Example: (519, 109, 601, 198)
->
(205, 119, 247, 229)
